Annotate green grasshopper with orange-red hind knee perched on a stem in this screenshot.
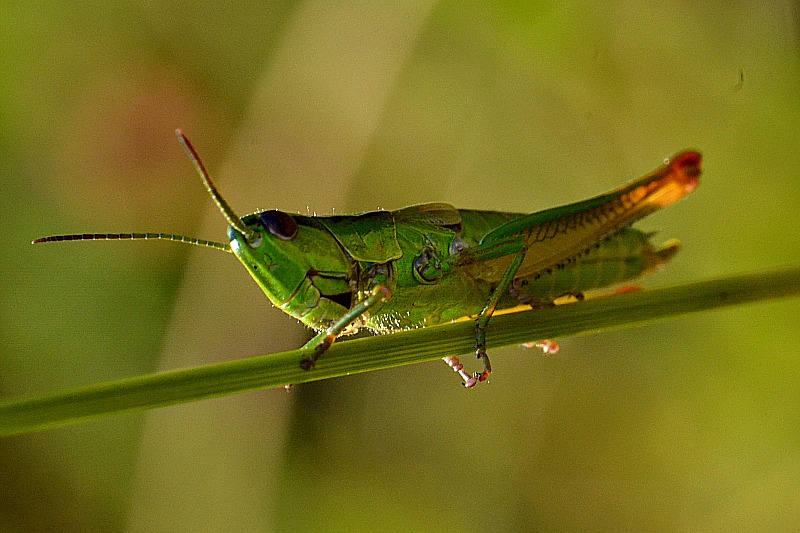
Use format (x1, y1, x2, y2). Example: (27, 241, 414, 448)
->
(33, 130, 701, 387)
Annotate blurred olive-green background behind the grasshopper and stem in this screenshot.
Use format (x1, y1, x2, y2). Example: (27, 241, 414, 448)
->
(0, 0, 800, 532)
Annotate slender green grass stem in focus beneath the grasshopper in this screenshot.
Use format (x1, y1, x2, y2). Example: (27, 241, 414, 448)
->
(0, 265, 800, 435)
